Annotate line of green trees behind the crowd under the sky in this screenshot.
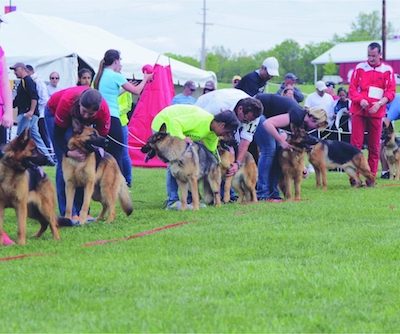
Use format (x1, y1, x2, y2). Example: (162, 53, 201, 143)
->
(167, 11, 394, 83)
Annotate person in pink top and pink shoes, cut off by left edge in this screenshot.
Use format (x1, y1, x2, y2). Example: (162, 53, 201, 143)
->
(0, 35, 14, 246)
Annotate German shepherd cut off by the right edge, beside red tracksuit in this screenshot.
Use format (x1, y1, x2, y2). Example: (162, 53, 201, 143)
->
(381, 123, 400, 180)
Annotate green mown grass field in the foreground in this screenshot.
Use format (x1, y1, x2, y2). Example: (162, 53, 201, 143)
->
(0, 168, 400, 333)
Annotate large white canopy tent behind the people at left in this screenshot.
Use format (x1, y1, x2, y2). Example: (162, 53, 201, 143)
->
(0, 12, 217, 87)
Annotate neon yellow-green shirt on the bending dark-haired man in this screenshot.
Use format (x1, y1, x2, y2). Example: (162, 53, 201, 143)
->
(151, 104, 218, 152)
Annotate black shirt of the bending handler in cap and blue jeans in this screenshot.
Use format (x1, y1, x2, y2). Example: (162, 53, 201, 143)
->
(255, 93, 306, 130)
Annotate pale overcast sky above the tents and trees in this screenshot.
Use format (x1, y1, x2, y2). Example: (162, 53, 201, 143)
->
(0, 0, 400, 58)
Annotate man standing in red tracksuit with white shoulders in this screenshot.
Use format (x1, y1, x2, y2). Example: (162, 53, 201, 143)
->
(349, 43, 396, 186)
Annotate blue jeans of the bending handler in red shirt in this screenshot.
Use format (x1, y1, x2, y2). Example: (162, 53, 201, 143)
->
(44, 107, 83, 216)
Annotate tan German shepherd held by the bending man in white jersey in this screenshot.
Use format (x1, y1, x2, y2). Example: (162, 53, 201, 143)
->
(218, 145, 258, 203)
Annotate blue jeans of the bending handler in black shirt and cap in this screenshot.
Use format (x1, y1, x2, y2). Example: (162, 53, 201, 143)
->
(254, 116, 280, 199)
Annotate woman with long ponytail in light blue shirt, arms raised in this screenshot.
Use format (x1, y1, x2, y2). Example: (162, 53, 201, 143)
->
(94, 49, 153, 172)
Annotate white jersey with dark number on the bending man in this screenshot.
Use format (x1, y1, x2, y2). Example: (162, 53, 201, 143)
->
(196, 88, 260, 143)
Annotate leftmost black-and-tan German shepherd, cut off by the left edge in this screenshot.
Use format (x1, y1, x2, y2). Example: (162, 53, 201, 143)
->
(0, 129, 60, 245)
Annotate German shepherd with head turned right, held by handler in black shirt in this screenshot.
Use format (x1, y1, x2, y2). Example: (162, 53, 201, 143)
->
(278, 125, 318, 201)
